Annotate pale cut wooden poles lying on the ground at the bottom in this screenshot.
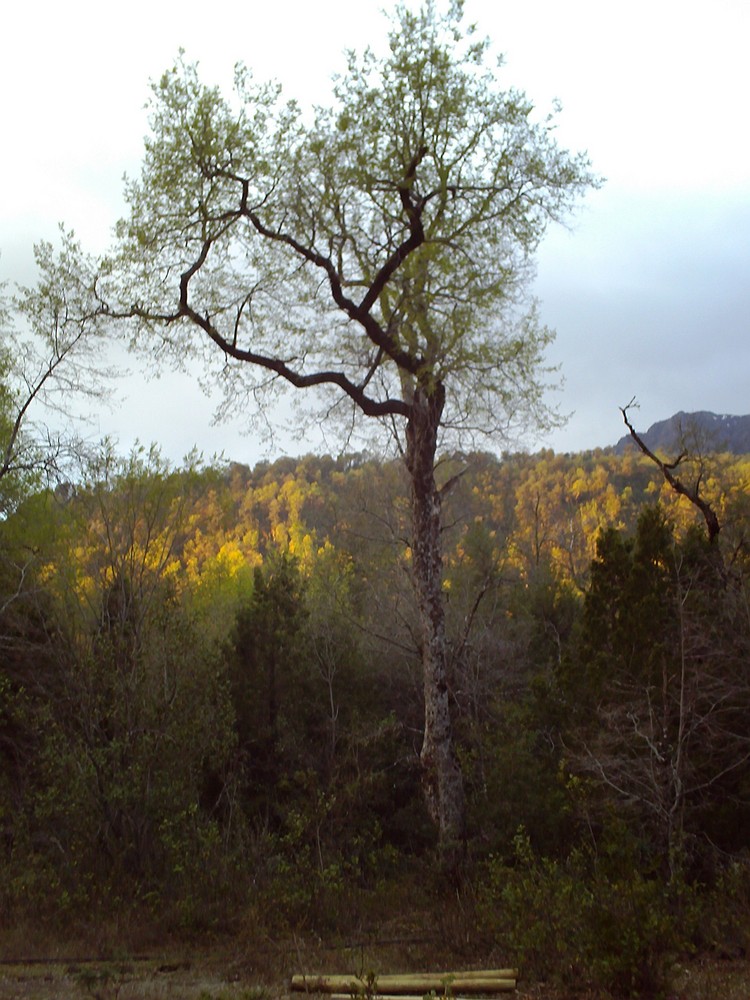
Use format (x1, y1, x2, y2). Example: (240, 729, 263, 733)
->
(292, 969, 518, 1000)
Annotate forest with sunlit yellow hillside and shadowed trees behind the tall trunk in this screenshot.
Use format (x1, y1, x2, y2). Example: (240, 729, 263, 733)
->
(0, 444, 750, 992)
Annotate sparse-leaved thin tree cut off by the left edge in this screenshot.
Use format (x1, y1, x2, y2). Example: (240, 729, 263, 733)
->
(0, 231, 113, 788)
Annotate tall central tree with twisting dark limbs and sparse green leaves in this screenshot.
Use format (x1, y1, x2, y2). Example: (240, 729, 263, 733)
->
(106, 0, 595, 862)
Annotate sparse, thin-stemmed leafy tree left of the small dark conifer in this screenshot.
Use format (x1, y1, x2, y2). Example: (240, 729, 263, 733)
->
(23, 446, 236, 892)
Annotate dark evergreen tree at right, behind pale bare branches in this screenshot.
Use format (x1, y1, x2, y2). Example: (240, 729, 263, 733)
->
(559, 507, 750, 878)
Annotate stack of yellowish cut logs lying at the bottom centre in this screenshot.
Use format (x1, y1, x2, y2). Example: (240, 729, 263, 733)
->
(292, 969, 518, 997)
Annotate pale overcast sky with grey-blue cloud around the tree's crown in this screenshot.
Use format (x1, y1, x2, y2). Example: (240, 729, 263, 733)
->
(0, 0, 750, 463)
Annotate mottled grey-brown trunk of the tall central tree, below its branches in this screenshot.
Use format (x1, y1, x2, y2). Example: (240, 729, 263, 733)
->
(406, 385, 465, 871)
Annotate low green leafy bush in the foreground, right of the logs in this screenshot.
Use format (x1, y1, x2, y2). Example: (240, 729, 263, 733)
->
(478, 831, 694, 997)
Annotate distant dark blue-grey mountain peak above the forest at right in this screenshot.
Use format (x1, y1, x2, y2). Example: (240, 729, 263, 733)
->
(614, 410, 750, 456)
